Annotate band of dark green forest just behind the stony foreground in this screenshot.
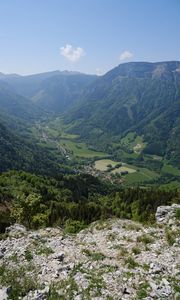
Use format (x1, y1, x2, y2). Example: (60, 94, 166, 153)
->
(0, 171, 180, 233)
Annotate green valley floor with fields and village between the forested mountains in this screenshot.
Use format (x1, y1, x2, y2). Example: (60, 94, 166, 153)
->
(27, 113, 180, 186)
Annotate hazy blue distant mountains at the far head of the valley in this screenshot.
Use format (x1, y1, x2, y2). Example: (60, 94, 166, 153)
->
(3, 71, 97, 113)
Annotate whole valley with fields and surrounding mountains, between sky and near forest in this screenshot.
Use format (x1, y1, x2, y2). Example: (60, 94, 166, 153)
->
(0, 62, 180, 202)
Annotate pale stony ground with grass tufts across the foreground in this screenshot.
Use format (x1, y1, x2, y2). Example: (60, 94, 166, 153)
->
(0, 207, 180, 300)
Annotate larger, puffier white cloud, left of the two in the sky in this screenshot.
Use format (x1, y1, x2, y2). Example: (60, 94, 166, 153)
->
(60, 44, 85, 62)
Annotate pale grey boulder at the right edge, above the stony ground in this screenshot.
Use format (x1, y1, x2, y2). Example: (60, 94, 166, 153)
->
(156, 204, 180, 225)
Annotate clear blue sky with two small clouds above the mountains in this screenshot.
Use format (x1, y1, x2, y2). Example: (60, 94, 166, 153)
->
(0, 0, 180, 74)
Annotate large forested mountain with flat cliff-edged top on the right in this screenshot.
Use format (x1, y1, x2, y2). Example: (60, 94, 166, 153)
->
(65, 61, 180, 162)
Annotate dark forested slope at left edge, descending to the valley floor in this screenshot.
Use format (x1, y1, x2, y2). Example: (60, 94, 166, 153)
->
(0, 118, 63, 175)
